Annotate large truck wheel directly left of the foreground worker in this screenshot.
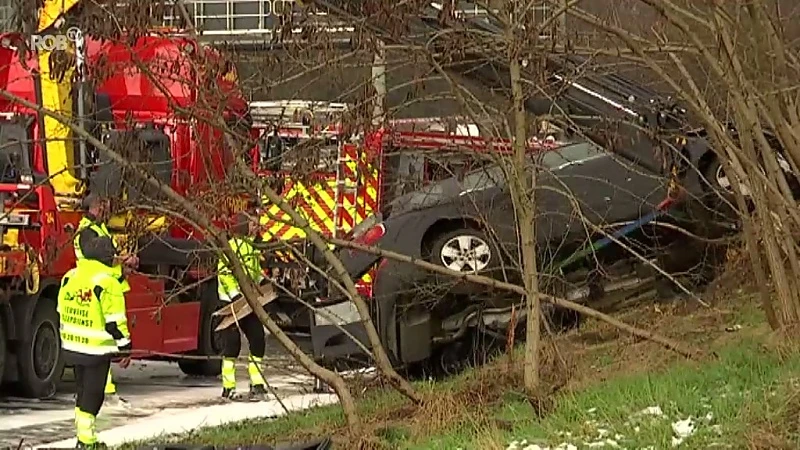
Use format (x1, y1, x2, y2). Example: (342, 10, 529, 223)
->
(18, 299, 64, 398)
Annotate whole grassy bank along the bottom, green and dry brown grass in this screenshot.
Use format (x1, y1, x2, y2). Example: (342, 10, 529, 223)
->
(123, 303, 800, 450)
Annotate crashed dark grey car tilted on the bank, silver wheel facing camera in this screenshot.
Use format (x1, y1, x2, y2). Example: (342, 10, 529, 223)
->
(300, 141, 724, 372)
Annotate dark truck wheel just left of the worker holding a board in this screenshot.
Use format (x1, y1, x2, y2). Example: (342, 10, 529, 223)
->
(178, 283, 223, 377)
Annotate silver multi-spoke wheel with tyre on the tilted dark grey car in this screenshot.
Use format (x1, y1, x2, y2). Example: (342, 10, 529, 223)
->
(428, 228, 500, 274)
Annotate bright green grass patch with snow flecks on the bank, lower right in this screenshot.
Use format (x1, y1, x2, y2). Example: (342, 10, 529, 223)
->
(407, 343, 800, 450)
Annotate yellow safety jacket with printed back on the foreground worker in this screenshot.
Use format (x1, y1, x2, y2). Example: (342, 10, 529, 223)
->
(58, 259, 131, 356)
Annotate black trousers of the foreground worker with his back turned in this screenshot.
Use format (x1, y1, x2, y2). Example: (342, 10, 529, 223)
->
(66, 352, 111, 416)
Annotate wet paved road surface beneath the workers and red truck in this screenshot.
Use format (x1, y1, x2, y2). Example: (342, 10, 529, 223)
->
(0, 356, 313, 449)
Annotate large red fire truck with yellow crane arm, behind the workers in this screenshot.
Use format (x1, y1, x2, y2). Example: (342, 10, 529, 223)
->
(0, 1, 246, 397)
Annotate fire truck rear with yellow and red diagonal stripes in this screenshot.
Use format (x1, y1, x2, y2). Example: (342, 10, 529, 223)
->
(247, 100, 380, 295)
